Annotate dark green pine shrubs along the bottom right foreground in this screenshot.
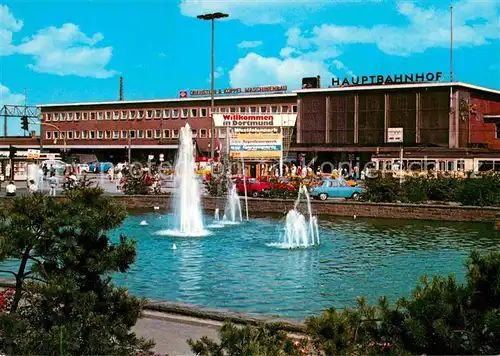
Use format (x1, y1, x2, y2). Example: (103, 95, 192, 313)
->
(189, 252, 500, 356)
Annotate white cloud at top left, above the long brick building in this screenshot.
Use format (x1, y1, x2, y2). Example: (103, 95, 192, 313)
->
(0, 6, 116, 78)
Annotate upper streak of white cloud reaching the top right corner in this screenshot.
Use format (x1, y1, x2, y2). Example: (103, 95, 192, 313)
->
(289, 0, 500, 56)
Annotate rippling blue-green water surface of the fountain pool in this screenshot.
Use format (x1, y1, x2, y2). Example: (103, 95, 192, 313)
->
(1, 213, 500, 318)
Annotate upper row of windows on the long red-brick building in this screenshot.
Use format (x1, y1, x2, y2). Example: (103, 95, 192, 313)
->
(45, 105, 297, 121)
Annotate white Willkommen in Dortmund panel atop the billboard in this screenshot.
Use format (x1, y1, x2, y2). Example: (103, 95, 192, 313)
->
(214, 114, 297, 128)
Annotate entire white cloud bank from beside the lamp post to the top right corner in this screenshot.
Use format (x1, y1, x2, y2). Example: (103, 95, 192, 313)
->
(229, 0, 500, 88)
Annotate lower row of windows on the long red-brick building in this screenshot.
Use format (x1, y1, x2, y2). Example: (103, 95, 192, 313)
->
(45, 129, 230, 140)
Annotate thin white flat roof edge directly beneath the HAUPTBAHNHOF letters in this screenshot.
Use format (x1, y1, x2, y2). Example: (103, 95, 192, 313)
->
(293, 82, 500, 95)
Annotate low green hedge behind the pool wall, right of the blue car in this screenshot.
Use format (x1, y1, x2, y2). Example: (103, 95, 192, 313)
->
(362, 174, 500, 206)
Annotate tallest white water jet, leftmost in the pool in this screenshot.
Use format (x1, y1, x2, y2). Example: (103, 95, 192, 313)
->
(170, 124, 207, 236)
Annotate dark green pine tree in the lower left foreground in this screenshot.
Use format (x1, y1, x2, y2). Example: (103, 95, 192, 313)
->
(0, 188, 153, 355)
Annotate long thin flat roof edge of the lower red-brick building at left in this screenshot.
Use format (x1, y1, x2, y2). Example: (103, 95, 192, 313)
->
(37, 93, 297, 108)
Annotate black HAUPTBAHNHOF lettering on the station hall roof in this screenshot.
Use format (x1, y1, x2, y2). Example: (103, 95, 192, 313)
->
(332, 72, 443, 86)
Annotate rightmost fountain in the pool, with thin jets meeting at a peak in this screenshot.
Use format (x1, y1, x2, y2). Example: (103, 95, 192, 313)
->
(269, 186, 320, 249)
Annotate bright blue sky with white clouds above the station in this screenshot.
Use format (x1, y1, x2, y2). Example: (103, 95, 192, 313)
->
(0, 0, 500, 134)
